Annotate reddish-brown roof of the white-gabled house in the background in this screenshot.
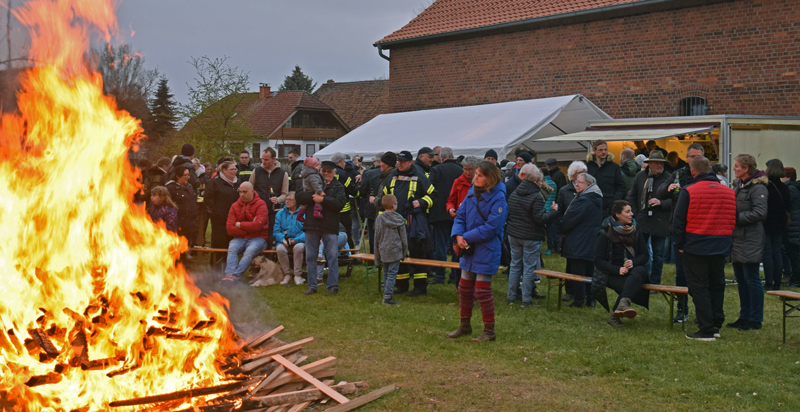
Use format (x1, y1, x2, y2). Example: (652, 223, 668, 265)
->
(241, 91, 333, 136)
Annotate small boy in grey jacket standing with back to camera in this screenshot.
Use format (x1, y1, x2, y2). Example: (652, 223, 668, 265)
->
(375, 195, 408, 305)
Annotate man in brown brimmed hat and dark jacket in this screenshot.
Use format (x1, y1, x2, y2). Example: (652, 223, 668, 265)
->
(630, 150, 672, 285)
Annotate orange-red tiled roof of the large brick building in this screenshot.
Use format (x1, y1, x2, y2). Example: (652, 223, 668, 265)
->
(375, 0, 652, 46)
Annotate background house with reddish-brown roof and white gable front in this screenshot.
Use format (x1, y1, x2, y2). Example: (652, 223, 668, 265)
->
(241, 84, 351, 162)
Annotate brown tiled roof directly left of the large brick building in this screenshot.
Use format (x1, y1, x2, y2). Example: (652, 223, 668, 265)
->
(314, 80, 389, 129)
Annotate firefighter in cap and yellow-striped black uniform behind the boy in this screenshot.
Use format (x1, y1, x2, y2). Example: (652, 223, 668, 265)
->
(374, 150, 437, 297)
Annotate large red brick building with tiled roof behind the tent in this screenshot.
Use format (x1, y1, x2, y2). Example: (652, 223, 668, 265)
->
(375, 0, 800, 118)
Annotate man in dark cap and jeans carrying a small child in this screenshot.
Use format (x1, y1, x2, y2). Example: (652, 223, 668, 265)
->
(295, 160, 347, 295)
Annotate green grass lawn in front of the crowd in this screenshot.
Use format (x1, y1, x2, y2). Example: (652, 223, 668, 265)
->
(189, 255, 800, 411)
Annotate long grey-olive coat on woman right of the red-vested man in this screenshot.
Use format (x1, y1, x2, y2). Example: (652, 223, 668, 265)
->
(731, 172, 768, 263)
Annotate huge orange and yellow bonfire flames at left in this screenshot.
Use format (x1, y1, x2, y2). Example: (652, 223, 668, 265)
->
(0, 0, 234, 411)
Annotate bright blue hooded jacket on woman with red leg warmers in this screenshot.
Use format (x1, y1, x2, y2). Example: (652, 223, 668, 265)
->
(451, 182, 508, 276)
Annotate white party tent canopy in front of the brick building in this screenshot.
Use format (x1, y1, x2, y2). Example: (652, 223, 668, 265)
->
(314, 94, 611, 160)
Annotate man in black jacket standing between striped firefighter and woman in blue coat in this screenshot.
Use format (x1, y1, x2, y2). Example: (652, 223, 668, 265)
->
(428, 147, 464, 284)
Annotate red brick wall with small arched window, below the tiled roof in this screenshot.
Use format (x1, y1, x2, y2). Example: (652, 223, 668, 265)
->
(389, 0, 800, 118)
